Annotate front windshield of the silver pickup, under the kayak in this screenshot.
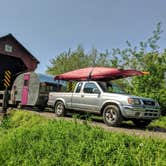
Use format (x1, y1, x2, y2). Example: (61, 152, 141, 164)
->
(98, 82, 126, 94)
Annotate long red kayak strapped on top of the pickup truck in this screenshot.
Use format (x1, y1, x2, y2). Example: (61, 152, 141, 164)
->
(55, 67, 148, 81)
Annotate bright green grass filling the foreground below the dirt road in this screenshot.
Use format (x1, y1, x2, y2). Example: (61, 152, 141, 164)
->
(0, 111, 166, 166)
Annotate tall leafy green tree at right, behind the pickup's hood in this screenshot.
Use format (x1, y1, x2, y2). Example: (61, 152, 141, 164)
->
(113, 23, 166, 113)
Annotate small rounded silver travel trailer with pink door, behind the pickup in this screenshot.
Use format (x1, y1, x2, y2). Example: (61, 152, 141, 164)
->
(10, 72, 65, 108)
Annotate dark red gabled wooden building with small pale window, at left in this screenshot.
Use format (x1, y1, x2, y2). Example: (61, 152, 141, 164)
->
(0, 34, 39, 90)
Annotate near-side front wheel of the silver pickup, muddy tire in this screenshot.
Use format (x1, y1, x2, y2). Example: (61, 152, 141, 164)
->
(103, 105, 122, 127)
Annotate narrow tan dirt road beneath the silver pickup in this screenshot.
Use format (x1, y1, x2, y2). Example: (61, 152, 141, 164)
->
(25, 111, 166, 140)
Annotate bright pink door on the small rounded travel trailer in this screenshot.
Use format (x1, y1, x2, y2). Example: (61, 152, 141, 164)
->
(21, 74, 30, 105)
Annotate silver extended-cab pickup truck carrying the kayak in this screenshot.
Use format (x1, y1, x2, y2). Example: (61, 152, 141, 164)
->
(48, 81, 160, 127)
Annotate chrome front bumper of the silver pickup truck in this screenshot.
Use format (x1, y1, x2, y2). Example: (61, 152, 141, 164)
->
(122, 105, 160, 119)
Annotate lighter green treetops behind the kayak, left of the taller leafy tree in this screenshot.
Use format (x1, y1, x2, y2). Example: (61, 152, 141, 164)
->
(47, 45, 112, 75)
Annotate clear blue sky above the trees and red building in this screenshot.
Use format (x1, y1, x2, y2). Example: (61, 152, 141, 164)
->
(0, 0, 166, 73)
